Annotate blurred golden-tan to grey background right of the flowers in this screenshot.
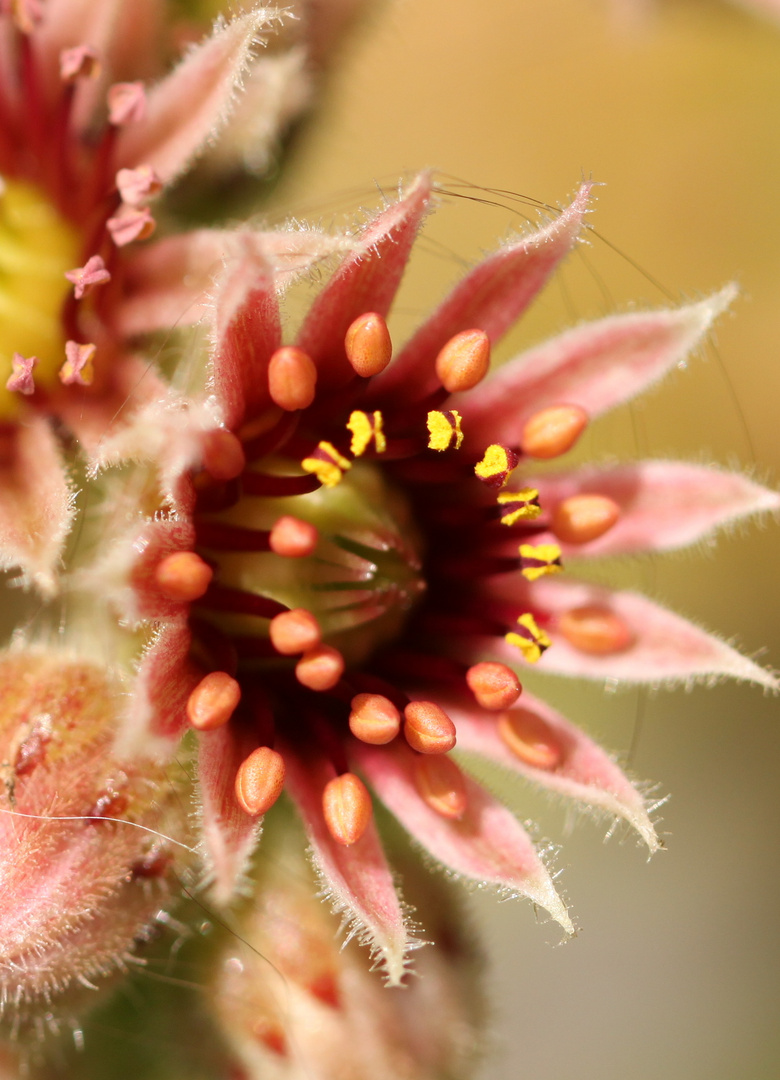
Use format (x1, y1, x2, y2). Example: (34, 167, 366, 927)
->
(262, 0, 780, 1080)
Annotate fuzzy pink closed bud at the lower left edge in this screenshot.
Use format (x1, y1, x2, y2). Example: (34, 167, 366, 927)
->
(0, 651, 189, 1029)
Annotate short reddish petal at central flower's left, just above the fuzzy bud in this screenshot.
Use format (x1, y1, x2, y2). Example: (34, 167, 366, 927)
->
(117, 619, 202, 757)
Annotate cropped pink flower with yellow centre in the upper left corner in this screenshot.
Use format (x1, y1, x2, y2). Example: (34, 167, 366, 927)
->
(0, 0, 343, 595)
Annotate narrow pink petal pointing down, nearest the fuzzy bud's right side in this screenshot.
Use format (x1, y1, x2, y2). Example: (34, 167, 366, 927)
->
(198, 724, 263, 907)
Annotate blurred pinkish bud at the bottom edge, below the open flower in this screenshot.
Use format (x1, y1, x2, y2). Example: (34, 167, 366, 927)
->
(212, 829, 480, 1080)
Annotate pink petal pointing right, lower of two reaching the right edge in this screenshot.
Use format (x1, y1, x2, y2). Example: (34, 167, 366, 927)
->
(489, 577, 780, 689)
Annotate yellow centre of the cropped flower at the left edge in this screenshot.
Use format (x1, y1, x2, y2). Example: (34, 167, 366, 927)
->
(0, 179, 79, 420)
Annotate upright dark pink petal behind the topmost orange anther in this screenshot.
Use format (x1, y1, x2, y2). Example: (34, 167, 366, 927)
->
(296, 173, 431, 387)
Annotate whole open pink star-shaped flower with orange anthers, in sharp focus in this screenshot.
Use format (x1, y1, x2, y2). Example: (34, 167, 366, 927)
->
(85, 174, 779, 983)
